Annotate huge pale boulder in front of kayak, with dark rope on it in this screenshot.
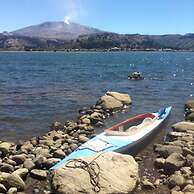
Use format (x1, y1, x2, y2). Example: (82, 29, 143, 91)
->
(52, 152, 139, 194)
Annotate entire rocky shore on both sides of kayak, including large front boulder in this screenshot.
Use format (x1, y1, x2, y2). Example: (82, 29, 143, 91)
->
(0, 92, 194, 194)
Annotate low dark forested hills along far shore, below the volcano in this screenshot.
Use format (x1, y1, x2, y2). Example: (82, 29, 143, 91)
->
(0, 32, 194, 51)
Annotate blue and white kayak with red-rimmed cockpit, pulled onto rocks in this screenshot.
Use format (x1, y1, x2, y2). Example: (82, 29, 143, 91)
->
(51, 107, 172, 169)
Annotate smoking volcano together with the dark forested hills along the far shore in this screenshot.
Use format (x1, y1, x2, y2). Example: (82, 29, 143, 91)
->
(0, 22, 194, 51)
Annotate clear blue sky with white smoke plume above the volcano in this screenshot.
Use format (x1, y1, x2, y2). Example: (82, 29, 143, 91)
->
(0, 0, 194, 34)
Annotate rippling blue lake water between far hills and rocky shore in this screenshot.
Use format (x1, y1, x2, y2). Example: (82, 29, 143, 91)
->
(0, 52, 194, 141)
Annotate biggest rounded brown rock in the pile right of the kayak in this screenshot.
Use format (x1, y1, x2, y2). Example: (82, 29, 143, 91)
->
(164, 153, 185, 173)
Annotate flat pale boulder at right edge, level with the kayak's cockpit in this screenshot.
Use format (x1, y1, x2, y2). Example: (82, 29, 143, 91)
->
(172, 121, 194, 132)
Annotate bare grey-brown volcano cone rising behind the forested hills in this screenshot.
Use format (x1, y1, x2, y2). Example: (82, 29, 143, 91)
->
(11, 22, 101, 40)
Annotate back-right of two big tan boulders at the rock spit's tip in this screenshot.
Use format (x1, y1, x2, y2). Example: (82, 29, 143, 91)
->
(106, 91, 132, 105)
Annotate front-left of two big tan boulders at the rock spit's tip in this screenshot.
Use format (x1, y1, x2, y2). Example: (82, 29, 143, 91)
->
(99, 95, 123, 110)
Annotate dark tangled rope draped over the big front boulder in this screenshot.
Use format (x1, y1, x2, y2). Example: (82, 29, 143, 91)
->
(65, 153, 102, 193)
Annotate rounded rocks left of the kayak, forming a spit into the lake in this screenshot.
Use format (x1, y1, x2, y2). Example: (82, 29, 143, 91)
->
(0, 92, 132, 194)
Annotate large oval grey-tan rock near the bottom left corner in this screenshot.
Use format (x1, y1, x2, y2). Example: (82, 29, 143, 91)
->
(7, 173, 25, 191)
